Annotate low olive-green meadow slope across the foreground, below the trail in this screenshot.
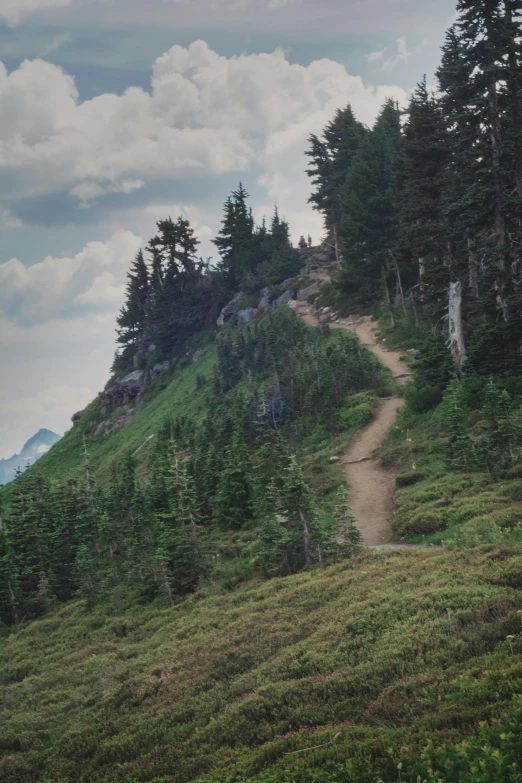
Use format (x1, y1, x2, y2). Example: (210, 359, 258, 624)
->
(0, 547, 522, 783)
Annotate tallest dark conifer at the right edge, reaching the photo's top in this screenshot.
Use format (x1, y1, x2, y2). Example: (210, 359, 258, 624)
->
(438, 0, 522, 355)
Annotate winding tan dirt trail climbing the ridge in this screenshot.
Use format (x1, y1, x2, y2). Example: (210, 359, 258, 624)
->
(296, 305, 408, 548)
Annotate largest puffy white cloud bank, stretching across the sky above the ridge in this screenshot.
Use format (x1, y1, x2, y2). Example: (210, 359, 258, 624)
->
(0, 41, 405, 207)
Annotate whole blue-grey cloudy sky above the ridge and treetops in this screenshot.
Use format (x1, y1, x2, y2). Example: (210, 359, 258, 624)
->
(0, 0, 455, 458)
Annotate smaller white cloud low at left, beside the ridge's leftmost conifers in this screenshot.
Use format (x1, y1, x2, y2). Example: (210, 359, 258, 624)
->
(0, 231, 141, 325)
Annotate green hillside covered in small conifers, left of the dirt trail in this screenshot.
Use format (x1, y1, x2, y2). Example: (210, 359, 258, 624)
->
(0, 309, 389, 625)
